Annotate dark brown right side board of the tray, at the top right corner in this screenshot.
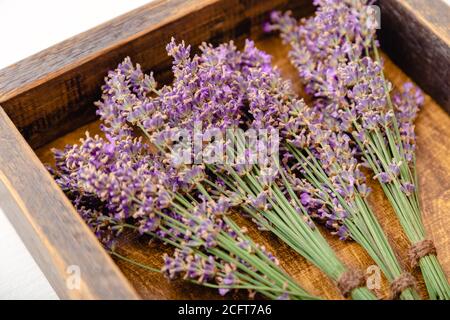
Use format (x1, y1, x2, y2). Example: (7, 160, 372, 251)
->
(378, 0, 450, 112)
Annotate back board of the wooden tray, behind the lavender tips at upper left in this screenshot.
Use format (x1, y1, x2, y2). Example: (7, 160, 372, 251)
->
(0, 0, 312, 147)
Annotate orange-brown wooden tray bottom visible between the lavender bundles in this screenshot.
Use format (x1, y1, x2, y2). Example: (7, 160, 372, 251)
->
(36, 38, 450, 299)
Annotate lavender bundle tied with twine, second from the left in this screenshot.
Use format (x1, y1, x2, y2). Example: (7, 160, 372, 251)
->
(90, 41, 375, 299)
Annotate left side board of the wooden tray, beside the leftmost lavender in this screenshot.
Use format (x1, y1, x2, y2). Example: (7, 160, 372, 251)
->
(0, 108, 137, 299)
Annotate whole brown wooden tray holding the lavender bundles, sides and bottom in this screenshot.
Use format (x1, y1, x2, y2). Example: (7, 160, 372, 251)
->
(0, 0, 450, 299)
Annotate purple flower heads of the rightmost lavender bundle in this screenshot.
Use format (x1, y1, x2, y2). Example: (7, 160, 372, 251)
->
(270, 0, 423, 206)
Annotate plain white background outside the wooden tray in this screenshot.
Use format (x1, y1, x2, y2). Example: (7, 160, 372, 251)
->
(0, 0, 450, 299)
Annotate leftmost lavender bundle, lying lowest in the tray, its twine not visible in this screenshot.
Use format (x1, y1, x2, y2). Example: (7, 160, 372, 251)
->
(51, 126, 317, 299)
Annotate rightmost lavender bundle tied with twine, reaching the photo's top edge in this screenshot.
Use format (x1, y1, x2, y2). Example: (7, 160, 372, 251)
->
(268, 0, 450, 299)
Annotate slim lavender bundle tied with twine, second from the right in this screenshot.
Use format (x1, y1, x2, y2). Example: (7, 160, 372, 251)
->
(241, 43, 419, 299)
